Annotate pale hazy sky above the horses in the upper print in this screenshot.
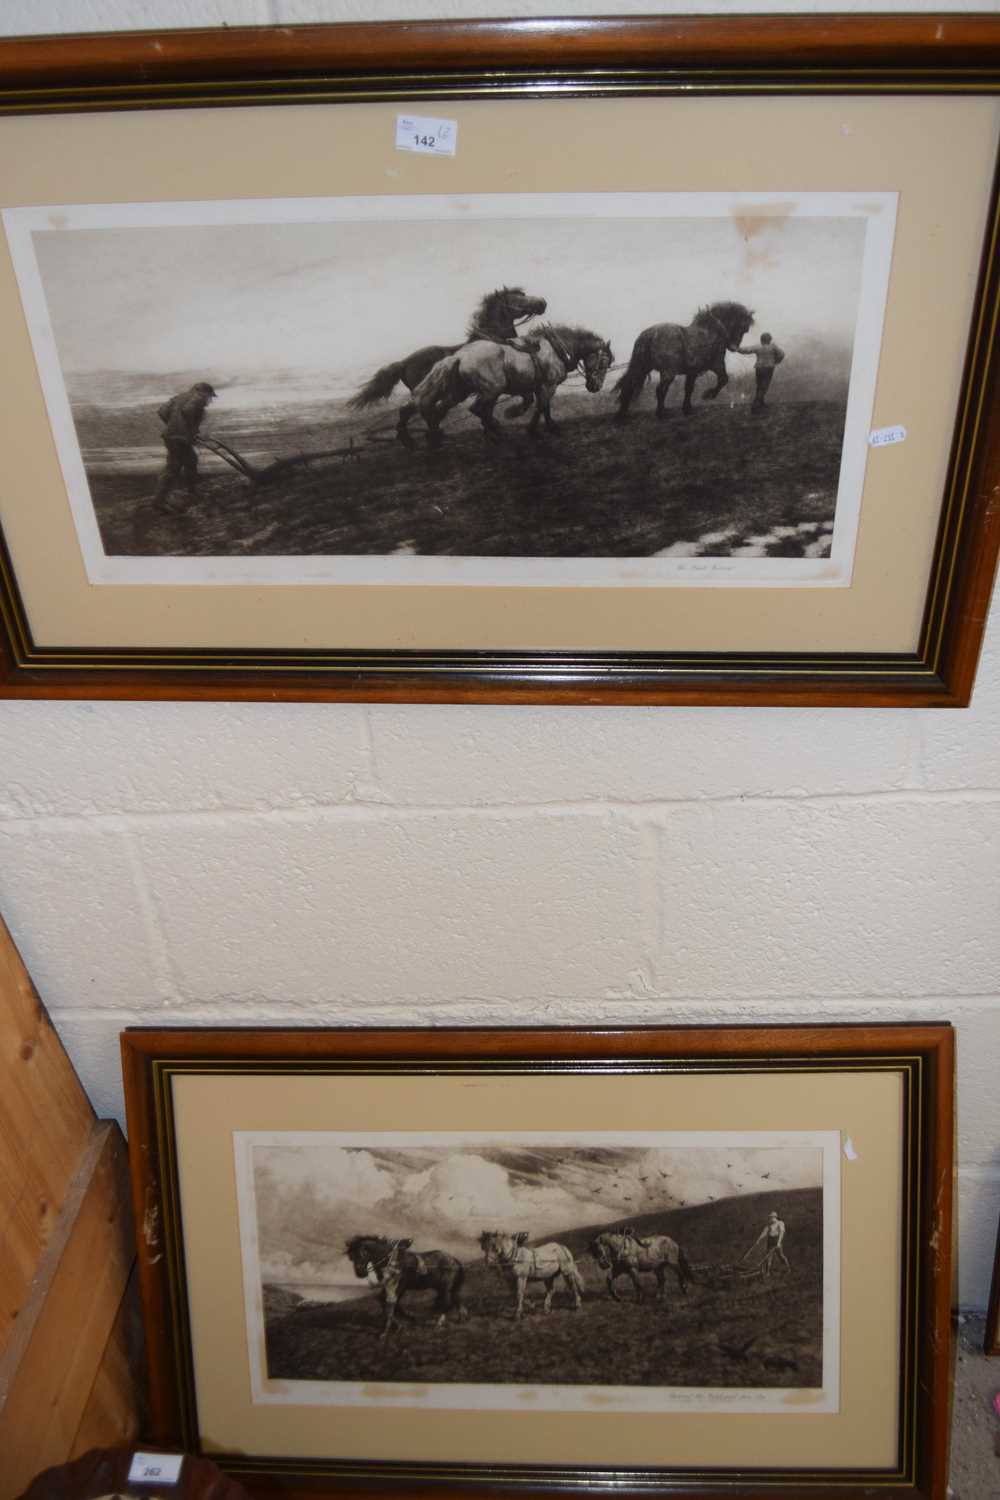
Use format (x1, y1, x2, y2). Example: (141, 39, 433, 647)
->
(21, 195, 867, 392)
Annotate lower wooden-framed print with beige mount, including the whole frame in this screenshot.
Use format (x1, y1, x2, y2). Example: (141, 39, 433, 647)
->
(121, 1026, 952, 1500)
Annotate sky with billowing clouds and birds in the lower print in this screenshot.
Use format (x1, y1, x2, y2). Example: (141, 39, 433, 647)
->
(245, 1134, 823, 1281)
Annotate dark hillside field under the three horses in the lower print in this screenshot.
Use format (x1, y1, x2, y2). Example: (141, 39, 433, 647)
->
(264, 1190, 823, 1389)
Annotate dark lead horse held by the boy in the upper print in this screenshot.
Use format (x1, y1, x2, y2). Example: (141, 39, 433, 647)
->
(615, 302, 754, 422)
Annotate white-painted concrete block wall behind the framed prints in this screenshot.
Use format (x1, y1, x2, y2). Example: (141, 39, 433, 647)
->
(0, 0, 1000, 1305)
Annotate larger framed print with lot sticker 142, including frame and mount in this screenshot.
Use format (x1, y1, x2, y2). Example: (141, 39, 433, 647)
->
(0, 17, 1000, 707)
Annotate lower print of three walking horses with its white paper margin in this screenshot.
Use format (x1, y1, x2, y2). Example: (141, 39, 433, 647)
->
(240, 1134, 835, 1398)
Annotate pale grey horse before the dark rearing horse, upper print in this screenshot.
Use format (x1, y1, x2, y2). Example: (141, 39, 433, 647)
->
(396, 323, 615, 449)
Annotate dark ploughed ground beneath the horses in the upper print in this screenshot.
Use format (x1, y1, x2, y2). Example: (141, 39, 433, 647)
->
(88, 392, 844, 558)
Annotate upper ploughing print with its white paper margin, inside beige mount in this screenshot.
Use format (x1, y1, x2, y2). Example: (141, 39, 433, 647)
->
(4, 194, 894, 585)
